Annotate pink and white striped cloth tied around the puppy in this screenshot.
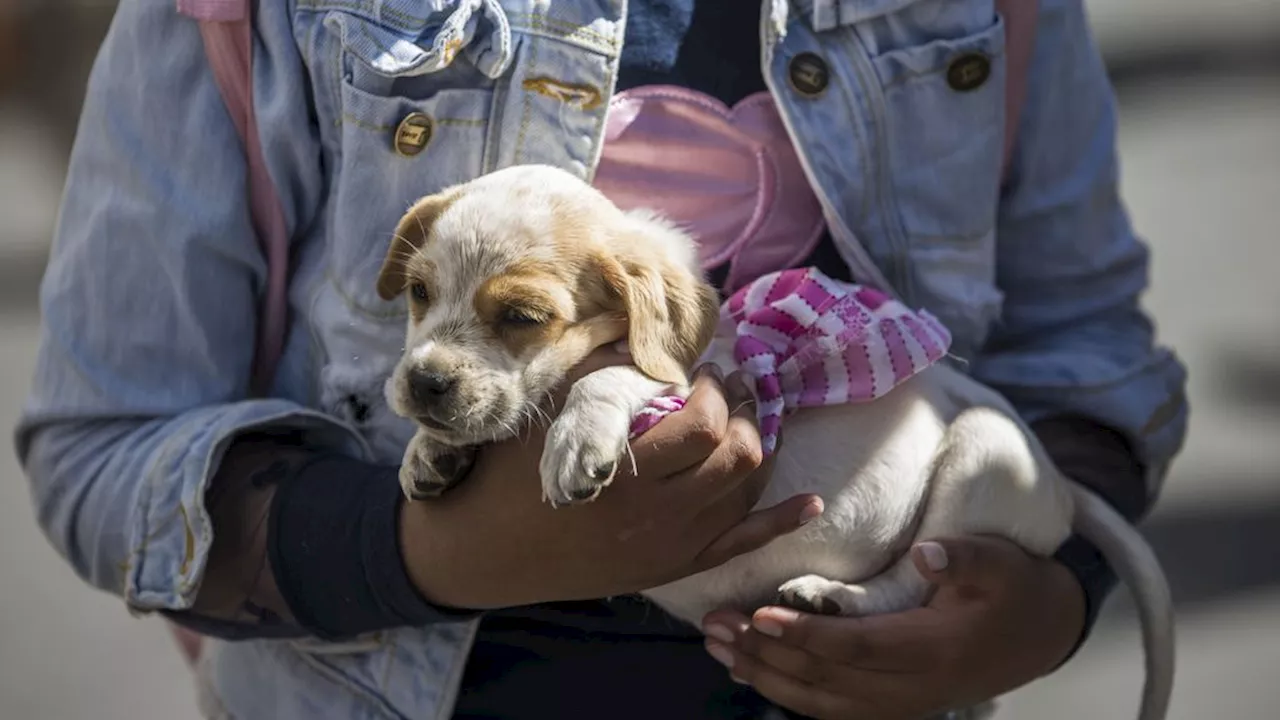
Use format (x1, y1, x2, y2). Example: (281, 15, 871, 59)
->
(631, 268, 951, 455)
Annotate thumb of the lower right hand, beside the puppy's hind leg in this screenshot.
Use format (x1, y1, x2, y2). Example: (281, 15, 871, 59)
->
(911, 536, 1027, 591)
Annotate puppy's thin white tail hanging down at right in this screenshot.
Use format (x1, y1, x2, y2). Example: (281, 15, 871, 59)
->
(1070, 483, 1174, 720)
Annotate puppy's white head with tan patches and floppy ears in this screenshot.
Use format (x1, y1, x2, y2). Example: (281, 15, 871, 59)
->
(378, 165, 718, 445)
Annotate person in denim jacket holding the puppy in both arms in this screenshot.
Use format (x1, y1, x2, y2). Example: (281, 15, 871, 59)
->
(18, 0, 1185, 719)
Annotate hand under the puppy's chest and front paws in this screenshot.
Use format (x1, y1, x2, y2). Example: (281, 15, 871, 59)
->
(401, 355, 822, 609)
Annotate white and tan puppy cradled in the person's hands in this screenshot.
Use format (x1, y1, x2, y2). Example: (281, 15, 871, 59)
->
(378, 167, 1172, 720)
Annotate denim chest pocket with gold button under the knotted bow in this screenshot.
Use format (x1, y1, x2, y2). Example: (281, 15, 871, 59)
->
(324, 0, 512, 315)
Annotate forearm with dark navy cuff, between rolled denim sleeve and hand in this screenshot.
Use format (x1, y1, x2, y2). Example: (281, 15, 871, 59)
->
(172, 434, 467, 639)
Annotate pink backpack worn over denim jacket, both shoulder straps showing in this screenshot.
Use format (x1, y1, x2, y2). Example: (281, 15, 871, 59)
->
(170, 0, 1038, 662)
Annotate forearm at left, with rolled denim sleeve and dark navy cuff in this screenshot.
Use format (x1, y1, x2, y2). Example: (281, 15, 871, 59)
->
(18, 401, 473, 638)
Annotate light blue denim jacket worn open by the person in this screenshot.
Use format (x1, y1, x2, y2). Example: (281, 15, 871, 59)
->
(17, 0, 1187, 719)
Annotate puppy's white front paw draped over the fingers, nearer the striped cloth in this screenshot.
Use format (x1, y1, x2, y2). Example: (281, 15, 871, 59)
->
(539, 402, 631, 507)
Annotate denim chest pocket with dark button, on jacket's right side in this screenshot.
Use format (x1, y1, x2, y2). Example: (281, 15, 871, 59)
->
(840, 0, 1006, 354)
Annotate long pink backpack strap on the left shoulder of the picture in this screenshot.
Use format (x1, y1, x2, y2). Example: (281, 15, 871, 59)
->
(178, 0, 289, 395)
